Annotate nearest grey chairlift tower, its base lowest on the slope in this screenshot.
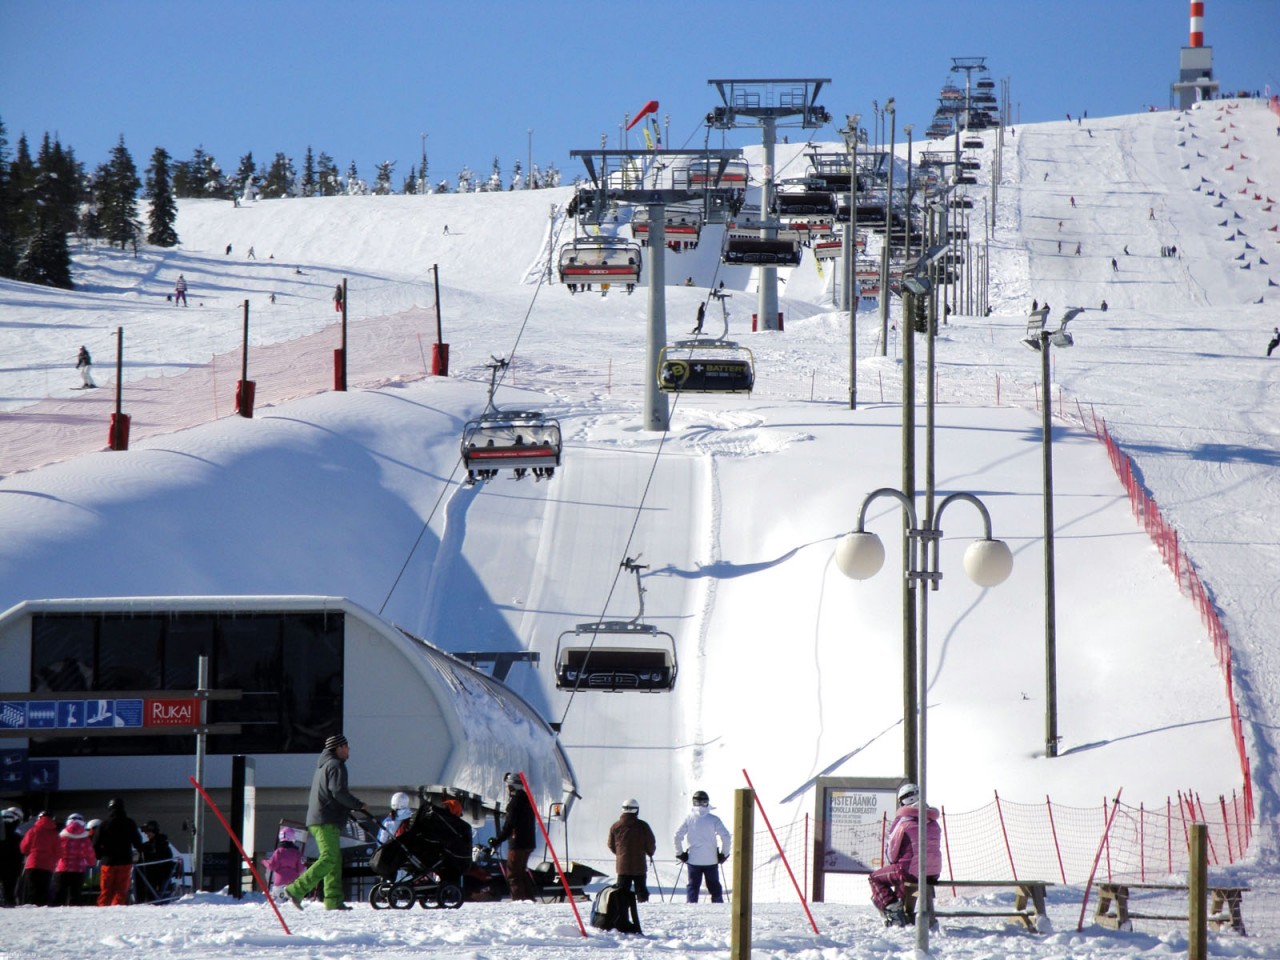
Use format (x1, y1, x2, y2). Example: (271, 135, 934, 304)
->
(570, 147, 742, 431)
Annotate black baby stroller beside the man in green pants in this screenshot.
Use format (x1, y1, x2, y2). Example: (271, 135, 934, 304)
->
(369, 803, 471, 910)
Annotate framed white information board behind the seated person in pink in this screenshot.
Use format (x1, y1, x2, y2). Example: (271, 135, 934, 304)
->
(814, 777, 902, 893)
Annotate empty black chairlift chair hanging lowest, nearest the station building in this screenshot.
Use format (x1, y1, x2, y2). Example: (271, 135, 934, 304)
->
(556, 557, 680, 692)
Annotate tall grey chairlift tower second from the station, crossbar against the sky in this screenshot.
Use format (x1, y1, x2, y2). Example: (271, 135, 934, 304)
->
(707, 79, 831, 330)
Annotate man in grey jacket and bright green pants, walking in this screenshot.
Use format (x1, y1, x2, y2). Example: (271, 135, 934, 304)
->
(284, 733, 370, 910)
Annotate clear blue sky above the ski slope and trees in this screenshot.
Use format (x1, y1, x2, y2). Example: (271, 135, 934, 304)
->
(0, 0, 1280, 186)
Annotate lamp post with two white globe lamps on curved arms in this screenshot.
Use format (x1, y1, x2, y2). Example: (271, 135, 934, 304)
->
(836, 486, 1014, 956)
